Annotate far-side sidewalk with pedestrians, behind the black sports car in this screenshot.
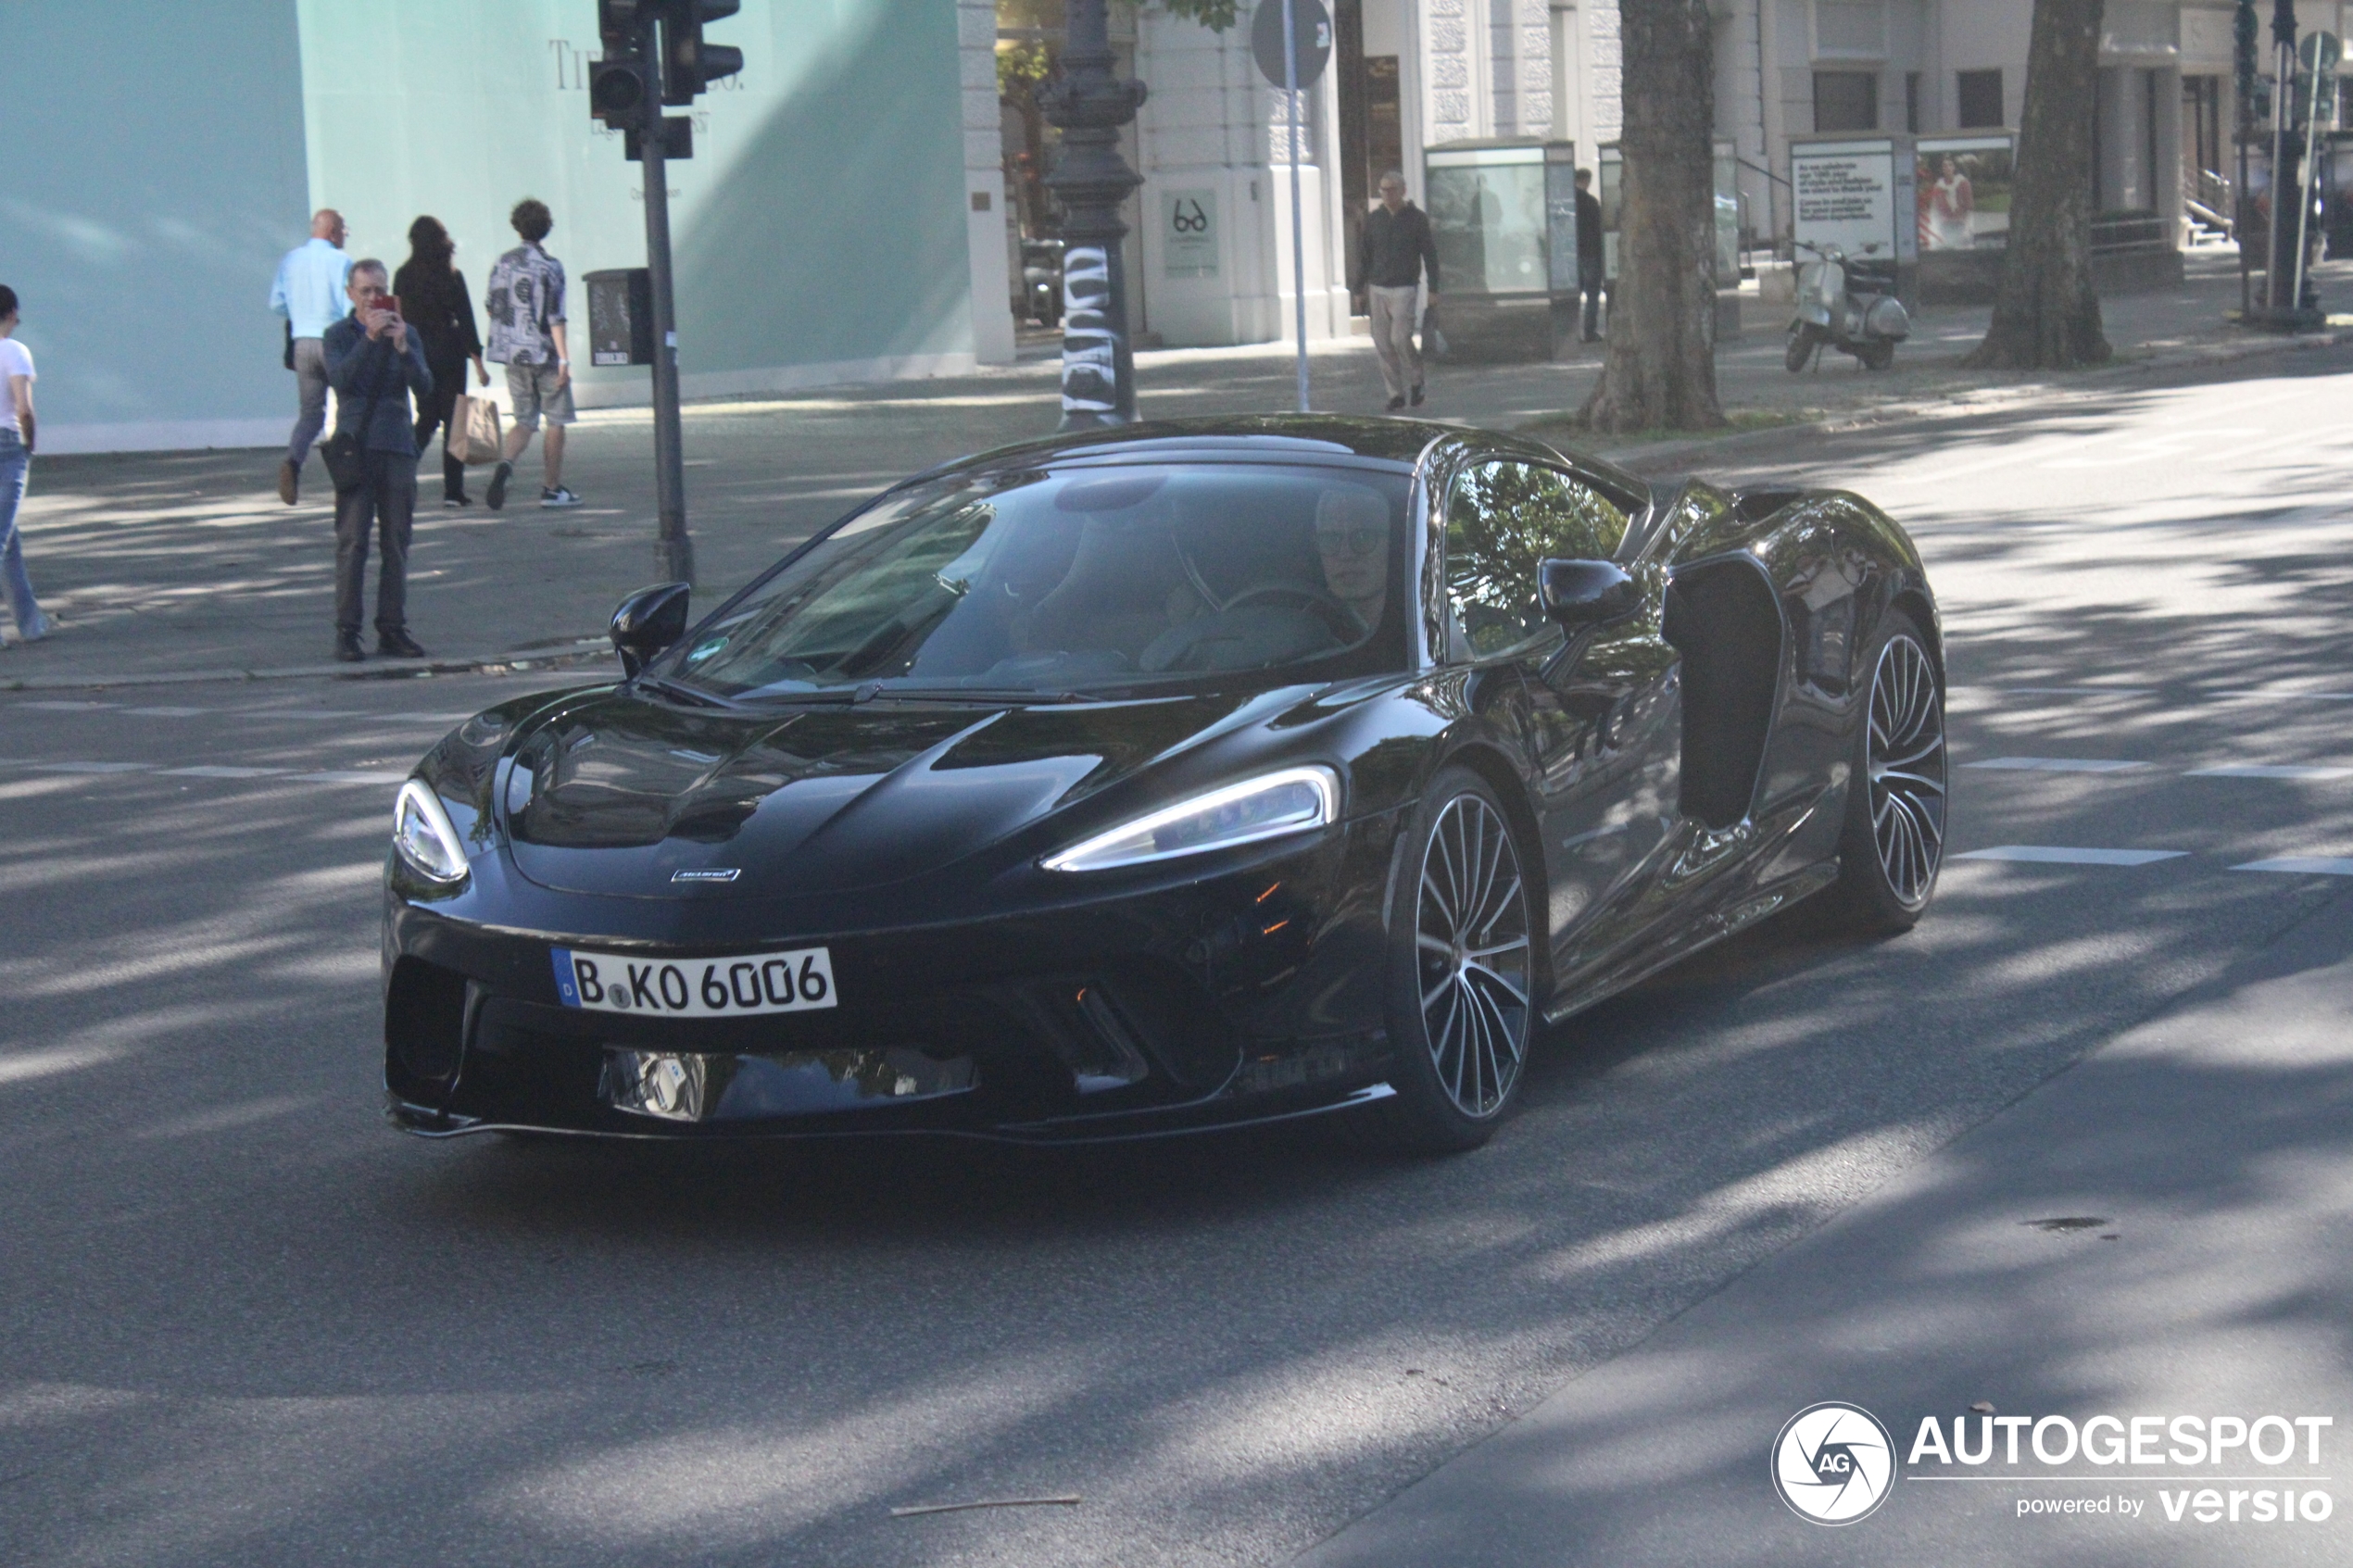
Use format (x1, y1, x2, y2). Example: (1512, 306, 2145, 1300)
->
(0, 252, 2353, 691)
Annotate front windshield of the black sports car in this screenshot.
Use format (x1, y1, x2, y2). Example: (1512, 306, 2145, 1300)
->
(657, 463, 1407, 700)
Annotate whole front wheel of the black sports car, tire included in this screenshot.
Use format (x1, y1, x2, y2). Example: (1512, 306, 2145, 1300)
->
(1377, 769, 1539, 1154)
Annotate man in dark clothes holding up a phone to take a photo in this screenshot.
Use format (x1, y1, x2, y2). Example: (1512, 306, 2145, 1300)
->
(320, 261, 433, 663)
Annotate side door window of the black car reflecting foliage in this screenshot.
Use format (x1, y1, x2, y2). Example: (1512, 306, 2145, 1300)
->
(1447, 463, 1626, 659)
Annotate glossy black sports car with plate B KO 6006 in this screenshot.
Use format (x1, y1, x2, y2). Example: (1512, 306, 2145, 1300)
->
(384, 416, 1946, 1152)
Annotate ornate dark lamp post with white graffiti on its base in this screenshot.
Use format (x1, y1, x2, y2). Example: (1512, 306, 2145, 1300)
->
(1038, 0, 1143, 430)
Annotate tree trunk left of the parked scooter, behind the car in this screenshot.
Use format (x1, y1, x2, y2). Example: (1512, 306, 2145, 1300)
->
(1579, 0, 1725, 433)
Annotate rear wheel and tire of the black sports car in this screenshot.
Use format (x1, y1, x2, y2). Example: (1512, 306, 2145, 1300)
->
(1821, 608, 1946, 935)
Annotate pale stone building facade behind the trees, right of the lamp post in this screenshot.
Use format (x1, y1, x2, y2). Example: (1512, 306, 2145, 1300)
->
(1049, 0, 2348, 344)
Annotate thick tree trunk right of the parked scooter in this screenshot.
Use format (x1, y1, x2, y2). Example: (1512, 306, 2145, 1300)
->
(1962, 0, 2108, 370)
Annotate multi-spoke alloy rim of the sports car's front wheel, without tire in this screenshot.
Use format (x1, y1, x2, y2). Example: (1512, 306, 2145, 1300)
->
(1415, 795, 1529, 1117)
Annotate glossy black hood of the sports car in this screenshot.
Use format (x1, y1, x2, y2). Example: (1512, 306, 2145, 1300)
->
(504, 691, 1297, 898)
